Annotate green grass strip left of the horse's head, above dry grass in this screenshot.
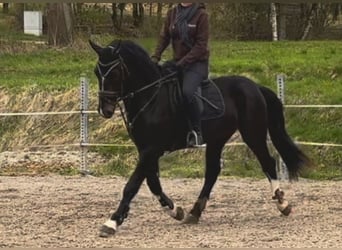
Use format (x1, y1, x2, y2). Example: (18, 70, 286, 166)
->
(0, 49, 95, 90)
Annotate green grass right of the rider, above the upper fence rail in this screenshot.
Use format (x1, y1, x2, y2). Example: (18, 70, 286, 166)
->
(211, 41, 342, 104)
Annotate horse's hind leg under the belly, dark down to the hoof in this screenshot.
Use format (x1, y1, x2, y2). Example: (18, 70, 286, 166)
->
(184, 142, 225, 224)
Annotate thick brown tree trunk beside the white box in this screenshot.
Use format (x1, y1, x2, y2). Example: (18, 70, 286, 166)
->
(47, 3, 73, 46)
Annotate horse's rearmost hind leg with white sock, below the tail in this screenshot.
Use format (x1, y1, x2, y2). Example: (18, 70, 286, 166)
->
(240, 130, 291, 215)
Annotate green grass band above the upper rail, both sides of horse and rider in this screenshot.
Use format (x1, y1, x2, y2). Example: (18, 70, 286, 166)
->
(0, 37, 342, 99)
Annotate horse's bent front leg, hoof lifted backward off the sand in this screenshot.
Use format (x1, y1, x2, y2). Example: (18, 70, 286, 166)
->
(146, 153, 184, 220)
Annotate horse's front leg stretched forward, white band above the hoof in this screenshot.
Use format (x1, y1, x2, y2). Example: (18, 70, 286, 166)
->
(100, 161, 145, 237)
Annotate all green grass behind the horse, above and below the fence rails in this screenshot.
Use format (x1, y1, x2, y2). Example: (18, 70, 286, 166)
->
(0, 30, 342, 179)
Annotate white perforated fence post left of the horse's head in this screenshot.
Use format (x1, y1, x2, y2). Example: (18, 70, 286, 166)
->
(80, 75, 89, 175)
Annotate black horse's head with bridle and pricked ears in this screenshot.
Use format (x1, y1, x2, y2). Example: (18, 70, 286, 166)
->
(89, 40, 127, 118)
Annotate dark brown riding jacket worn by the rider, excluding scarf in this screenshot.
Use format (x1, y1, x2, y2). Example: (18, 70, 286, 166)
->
(153, 4, 209, 66)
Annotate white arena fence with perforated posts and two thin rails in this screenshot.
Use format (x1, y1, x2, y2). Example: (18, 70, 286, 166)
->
(0, 74, 342, 180)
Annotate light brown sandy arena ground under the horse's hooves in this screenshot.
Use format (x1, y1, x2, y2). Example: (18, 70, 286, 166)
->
(0, 176, 342, 248)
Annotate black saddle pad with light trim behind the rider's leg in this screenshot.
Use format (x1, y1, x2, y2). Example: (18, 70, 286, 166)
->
(196, 79, 225, 121)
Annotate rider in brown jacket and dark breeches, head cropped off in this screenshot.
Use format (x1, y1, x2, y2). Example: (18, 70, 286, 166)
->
(151, 3, 209, 147)
